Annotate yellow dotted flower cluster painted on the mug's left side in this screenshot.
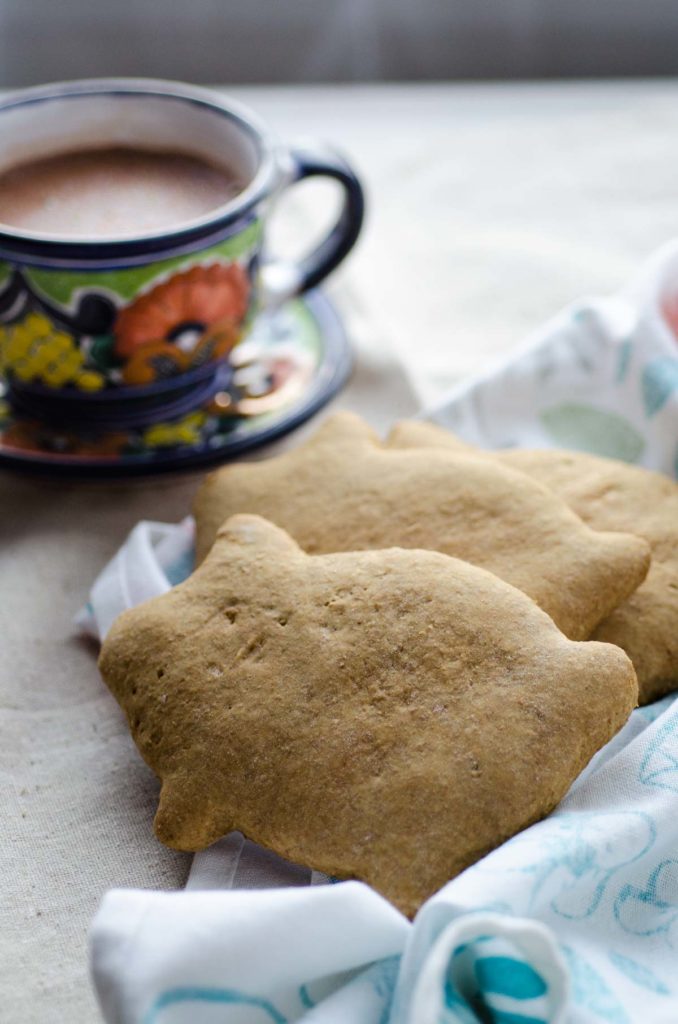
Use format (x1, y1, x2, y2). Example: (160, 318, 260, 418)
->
(0, 312, 104, 391)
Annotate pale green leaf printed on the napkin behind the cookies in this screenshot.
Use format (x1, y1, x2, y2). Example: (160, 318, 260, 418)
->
(540, 401, 645, 462)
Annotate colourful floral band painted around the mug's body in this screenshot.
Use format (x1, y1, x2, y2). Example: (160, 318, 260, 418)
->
(0, 231, 258, 394)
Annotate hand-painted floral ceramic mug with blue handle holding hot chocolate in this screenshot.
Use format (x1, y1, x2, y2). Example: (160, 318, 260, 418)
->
(0, 79, 364, 429)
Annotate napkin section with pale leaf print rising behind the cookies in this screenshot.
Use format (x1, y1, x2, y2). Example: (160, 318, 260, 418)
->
(422, 237, 678, 476)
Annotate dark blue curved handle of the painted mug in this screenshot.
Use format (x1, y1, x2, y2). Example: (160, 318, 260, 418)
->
(261, 148, 365, 309)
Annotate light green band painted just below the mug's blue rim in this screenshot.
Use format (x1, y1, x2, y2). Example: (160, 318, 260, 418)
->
(25, 220, 262, 305)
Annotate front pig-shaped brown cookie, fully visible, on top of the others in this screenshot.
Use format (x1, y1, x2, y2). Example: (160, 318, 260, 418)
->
(99, 516, 637, 914)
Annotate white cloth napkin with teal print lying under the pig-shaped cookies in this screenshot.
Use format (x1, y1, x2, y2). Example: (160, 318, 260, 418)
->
(79, 246, 678, 1024)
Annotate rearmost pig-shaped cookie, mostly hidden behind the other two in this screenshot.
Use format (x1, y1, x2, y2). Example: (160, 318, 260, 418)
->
(389, 421, 678, 703)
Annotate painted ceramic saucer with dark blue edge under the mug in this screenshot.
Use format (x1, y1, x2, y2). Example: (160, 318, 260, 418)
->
(0, 291, 351, 476)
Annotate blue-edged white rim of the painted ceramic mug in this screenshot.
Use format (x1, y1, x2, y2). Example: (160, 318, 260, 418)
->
(0, 78, 280, 269)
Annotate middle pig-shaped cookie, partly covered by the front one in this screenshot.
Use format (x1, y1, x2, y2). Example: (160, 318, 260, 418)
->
(195, 413, 649, 640)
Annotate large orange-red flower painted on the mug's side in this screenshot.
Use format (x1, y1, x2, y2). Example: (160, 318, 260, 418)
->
(114, 263, 250, 359)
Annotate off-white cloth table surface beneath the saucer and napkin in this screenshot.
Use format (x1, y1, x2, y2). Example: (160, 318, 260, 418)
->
(0, 82, 678, 1024)
